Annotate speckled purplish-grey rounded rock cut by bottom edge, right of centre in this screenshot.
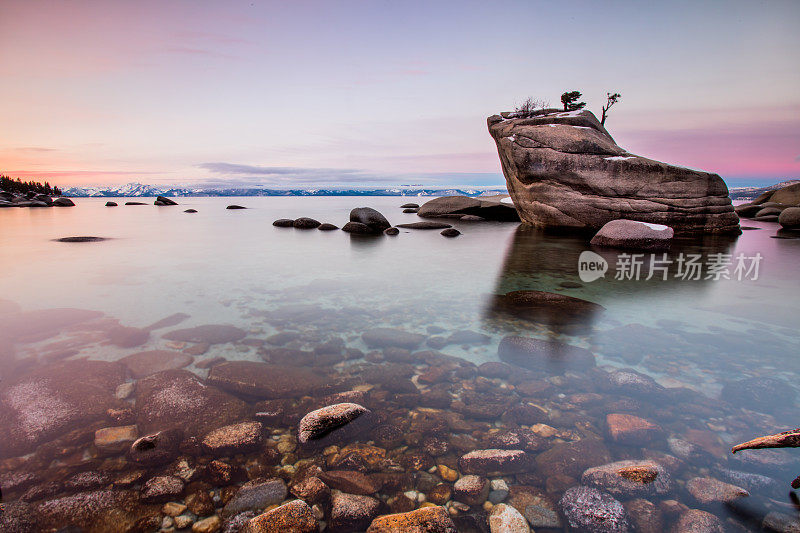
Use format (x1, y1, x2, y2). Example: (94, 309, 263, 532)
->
(558, 487, 630, 533)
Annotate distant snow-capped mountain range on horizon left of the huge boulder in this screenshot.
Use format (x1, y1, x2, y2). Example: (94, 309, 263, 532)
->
(63, 183, 508, 198)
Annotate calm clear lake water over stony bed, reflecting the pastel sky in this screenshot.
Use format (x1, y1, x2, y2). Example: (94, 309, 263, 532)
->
(0, 197, 800, 531)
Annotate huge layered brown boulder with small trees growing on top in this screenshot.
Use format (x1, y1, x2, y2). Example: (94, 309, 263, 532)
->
(490, 110, 740, 234)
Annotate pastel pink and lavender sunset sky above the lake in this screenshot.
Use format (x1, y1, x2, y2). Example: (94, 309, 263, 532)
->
(0, 0, 800, 187)
